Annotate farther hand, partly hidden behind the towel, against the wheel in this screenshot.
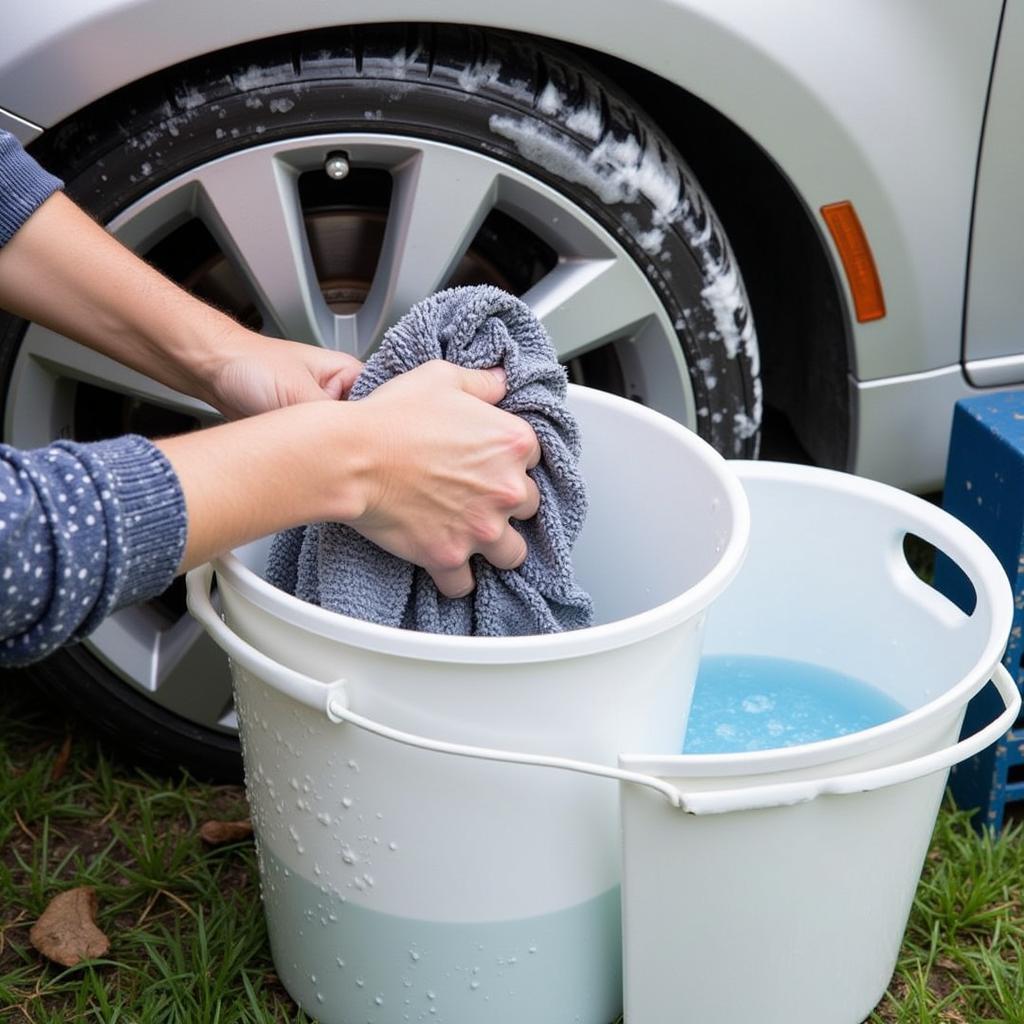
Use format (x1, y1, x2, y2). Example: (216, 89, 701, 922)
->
(195, 328, 362, 420)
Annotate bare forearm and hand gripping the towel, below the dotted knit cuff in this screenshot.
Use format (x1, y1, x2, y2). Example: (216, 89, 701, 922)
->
(158, 360, 541, 597)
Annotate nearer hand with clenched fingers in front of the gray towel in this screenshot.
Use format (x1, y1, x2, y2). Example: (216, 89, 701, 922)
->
(348, 360, 541, 597)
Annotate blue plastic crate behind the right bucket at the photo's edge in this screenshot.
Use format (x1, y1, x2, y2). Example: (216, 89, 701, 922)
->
(935, 392, 1024, 831)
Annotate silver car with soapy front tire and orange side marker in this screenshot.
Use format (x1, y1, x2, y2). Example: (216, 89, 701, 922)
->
(0, 0, 1011, 775)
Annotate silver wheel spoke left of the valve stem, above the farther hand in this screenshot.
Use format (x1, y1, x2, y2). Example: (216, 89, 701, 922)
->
(197, 150, 335, 347)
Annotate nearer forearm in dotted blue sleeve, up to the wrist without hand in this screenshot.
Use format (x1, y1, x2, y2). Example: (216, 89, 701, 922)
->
(0, 402, 379, 665)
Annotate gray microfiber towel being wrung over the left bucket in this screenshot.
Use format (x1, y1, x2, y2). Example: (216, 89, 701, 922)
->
(266, 286, 593, 637)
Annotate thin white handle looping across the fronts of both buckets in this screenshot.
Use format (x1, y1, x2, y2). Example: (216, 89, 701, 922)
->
(187, 563, 1021, 814)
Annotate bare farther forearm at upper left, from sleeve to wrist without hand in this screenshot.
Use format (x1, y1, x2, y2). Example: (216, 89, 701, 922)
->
(0, 193, 241, 400)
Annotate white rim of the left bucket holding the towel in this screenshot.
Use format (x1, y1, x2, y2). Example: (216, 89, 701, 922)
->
(212, 384, 751, 665)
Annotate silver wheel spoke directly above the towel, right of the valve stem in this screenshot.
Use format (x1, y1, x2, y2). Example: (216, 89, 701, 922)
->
(356, 146, 498, 357)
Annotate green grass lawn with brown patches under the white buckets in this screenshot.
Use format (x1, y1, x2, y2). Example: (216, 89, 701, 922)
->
(0, 674, 1024, 1024)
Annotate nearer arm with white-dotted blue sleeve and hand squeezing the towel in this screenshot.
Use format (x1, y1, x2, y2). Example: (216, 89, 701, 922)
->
(0, 362, 540, 665)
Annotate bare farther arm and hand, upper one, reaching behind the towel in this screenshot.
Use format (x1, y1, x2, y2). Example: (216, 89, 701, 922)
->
(0, 193, 361, 419)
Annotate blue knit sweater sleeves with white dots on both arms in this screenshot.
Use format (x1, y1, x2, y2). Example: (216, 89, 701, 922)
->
(0, 131, 186, 666)
